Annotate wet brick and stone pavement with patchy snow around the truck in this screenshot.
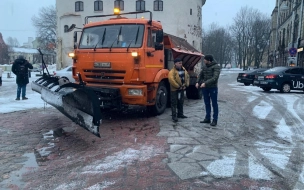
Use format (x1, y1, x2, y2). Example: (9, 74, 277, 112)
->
(0, 72, 304, 190)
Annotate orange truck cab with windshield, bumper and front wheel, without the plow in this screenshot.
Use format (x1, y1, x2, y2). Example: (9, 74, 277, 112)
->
(69, 11, 201, 114)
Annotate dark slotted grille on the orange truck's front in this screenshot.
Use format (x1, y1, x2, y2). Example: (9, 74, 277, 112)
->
(83, 69, 126, 83)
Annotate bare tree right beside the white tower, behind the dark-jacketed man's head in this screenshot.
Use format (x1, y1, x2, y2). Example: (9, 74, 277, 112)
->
(203, 23, 234, 67)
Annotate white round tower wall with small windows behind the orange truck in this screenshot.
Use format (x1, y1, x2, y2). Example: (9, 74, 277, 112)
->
(56, 0, 206, 69)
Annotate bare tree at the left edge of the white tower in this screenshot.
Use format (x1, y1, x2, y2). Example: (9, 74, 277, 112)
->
(32, 6, 57, 53)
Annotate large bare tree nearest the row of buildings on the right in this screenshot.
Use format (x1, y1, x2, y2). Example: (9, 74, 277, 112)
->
(231, 7, 271, 68)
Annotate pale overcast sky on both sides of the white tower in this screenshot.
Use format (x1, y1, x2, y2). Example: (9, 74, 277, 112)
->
(0, 0, 275, 45)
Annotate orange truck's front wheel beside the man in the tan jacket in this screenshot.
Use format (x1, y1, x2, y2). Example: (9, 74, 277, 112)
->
(147, 81, 168, 115)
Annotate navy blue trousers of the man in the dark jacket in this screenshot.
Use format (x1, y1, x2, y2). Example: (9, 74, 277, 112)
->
(202, 88, 218, 121)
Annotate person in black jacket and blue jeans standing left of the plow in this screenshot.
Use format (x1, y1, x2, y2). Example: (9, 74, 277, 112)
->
(12, 55, 33, 100)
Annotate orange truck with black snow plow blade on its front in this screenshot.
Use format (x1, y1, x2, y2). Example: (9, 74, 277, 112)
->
(32, 11, 203, 137)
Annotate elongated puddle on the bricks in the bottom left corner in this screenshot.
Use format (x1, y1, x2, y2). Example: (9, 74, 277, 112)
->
(0, 153, 39, 190)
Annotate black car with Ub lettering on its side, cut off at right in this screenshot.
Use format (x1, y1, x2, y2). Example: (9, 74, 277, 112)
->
(254, 67, 304, 92)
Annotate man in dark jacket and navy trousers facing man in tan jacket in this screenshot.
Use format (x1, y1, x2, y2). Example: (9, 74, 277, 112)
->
(195, 55, 221, 126)
